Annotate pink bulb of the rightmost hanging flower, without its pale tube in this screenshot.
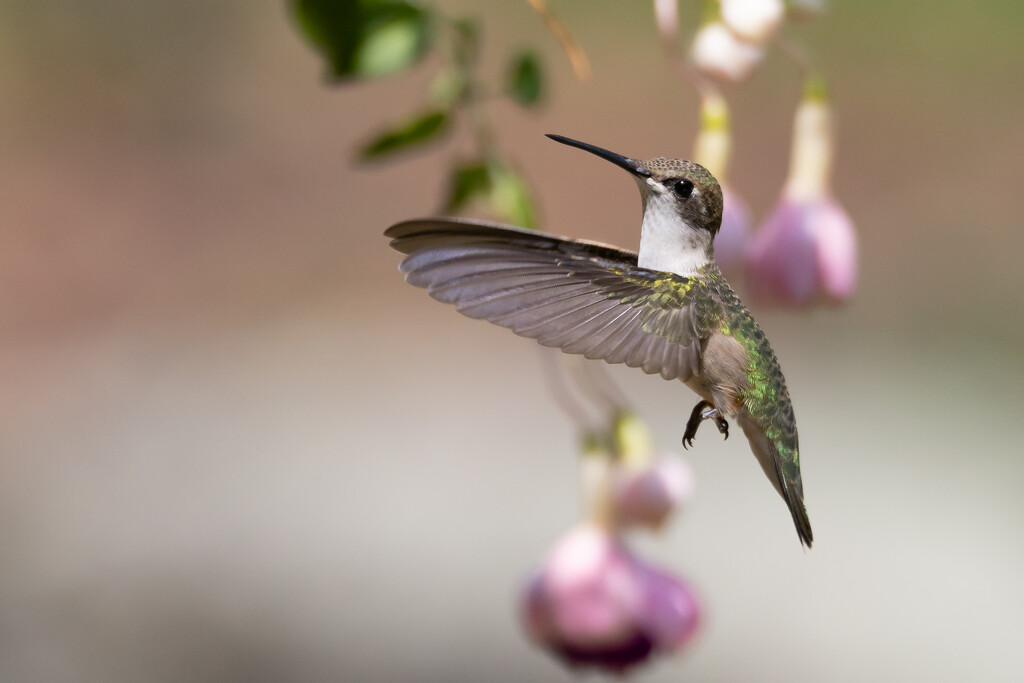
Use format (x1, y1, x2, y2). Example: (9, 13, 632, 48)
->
(746, 197, 857, 307)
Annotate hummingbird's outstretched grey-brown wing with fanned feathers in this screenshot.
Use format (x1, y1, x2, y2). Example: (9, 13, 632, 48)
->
(385, 218, 708, 381)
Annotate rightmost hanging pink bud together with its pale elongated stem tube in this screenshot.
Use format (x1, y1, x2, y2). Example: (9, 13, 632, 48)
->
(746, 83, 857, 307)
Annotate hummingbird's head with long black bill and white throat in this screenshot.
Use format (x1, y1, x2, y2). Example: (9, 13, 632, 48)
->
(548, 135, 722, 271)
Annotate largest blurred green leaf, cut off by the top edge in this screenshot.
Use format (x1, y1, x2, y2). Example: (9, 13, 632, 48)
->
(292, 0, 432, 80)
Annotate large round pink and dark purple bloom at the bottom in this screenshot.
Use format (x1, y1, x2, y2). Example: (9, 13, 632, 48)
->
(522, 523, 699, 673)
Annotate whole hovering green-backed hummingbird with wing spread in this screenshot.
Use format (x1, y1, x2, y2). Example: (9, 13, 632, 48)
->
(385, 135, 813, 547)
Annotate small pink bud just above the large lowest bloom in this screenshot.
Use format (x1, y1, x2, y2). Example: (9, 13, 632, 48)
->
(612, 456, 694, 529)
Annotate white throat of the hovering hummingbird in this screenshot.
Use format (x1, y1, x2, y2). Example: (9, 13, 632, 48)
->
(637, 178, 711, 276)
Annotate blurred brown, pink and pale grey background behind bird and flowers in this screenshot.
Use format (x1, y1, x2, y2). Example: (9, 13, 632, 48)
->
(0, 0, 1024, 683)
